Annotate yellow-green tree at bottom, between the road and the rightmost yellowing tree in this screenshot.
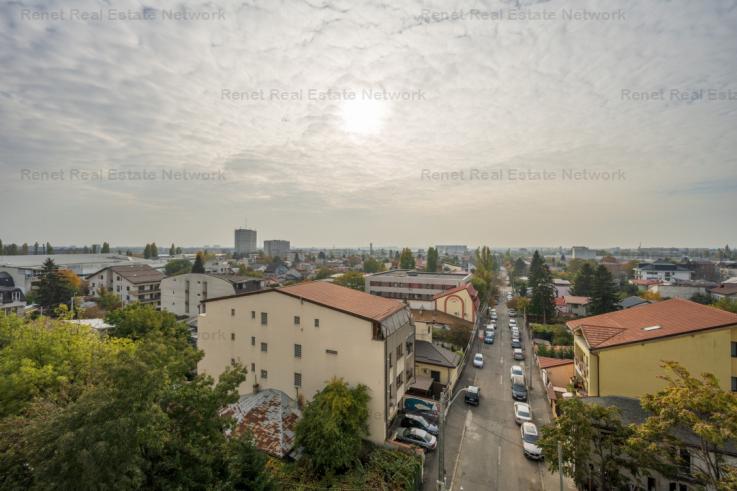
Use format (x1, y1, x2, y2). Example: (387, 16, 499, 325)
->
(538, 397, 641, 491)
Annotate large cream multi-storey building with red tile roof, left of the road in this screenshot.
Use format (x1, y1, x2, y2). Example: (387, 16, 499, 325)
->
(198, 281, 415, 443)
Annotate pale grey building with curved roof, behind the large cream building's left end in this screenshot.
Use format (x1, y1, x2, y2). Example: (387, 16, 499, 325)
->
(161, 273, 263, 317)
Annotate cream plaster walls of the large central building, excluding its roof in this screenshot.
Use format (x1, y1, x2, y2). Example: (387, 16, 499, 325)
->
(198, 291, 414, 443)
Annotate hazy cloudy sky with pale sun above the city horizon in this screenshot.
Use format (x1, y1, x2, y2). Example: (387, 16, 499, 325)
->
(0, 0, 737, 250)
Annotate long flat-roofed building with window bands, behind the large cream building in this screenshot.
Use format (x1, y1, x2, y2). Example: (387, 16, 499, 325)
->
(365, 269, 471, 310)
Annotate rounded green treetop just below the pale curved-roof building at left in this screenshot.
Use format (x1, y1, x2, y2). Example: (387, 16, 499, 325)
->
(105, 303, 189, 341)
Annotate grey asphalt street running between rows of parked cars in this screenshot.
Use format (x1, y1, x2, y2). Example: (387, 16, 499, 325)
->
(423, 280, 575, 491)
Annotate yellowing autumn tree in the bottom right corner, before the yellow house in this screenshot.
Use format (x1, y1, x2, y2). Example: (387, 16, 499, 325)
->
(631, 361, 737, 491)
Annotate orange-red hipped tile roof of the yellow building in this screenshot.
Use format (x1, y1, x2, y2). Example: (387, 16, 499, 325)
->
(566, 298, 737, 349)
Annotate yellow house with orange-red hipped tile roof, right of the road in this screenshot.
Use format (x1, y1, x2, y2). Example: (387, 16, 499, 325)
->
(566, 298, 737, 397)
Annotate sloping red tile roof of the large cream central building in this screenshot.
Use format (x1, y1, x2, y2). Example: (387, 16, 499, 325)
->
(277, 281, 406, 321)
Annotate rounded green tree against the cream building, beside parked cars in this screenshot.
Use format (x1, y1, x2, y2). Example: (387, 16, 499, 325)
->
(295, 378, 370, 475)
